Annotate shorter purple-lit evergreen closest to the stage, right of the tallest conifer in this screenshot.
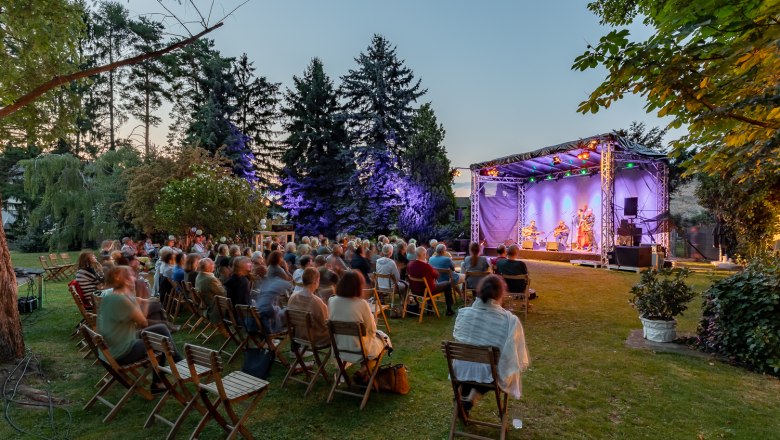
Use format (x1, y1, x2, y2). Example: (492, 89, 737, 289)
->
(398, 103, 455, 238)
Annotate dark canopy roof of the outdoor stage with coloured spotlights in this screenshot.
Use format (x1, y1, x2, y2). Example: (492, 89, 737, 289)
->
(469, 133, 666, 178)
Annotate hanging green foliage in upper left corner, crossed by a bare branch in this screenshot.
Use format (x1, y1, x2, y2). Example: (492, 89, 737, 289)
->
(0, 0, 85, 143)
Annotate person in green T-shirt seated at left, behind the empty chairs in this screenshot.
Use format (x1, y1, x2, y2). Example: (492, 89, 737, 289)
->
(97, 266, 182, 391)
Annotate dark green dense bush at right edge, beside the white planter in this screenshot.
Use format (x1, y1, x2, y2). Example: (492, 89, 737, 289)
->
(698, 257, 780, 376)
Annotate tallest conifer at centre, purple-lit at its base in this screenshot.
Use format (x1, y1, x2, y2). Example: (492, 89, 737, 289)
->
(341, 35, 425, 233)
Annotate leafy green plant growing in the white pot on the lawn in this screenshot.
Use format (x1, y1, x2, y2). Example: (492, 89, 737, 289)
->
(629, 269, 696, 321)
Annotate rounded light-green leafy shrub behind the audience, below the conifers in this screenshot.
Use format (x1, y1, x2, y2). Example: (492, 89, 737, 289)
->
(154, 165, 267, 237)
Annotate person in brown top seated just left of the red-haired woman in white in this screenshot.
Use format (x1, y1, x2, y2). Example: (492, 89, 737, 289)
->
(287, 266, 330, 346)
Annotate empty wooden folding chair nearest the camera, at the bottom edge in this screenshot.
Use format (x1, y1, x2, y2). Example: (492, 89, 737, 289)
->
(184, 344, 268, 440)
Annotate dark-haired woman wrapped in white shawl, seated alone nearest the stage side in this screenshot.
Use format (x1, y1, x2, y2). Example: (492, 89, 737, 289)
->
(452, 275, 528, 411)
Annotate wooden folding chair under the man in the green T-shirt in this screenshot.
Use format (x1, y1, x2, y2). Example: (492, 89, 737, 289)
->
(81, 325, 153, 423)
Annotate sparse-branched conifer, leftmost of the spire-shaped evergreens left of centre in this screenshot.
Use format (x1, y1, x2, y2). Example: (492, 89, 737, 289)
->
(232, 54, 284, 188)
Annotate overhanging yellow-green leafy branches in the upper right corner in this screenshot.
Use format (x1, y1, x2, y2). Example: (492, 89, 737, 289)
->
(572, 0, 780, 216)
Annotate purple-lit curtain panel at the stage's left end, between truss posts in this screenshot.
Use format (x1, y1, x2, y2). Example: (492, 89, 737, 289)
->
(479, 183, 517, 247)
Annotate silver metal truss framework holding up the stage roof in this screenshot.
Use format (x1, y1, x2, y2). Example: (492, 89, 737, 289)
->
(471, 136, 669, 267)
